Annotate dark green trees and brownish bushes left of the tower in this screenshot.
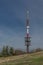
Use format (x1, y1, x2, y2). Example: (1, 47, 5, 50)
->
(0, 46, 25, 57)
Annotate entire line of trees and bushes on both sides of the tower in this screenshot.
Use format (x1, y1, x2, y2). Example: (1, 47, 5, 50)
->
(0, 46, 43, 57)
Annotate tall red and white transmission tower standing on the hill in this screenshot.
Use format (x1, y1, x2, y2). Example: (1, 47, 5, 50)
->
(25, 11, 31, 53)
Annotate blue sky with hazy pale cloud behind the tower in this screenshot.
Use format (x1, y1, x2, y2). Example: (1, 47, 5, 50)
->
(0, 0, 43, 49)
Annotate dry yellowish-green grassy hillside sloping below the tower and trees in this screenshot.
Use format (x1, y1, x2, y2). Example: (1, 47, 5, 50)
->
(0, 52, 43, 65)
